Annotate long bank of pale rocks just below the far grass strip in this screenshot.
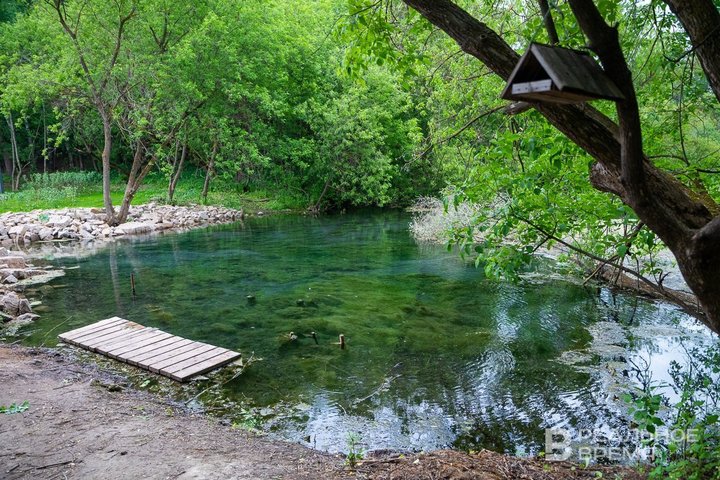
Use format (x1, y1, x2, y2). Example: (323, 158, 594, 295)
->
(0, 203, 244, 245)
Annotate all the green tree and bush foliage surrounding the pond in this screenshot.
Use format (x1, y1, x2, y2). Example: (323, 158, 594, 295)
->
(0, 0, 720, 316)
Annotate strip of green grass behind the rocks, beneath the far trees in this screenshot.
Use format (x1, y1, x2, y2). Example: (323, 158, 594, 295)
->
(0, 172, 309, 213)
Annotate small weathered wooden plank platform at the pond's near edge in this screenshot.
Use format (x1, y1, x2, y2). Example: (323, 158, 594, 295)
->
(58, 317, 240, 382)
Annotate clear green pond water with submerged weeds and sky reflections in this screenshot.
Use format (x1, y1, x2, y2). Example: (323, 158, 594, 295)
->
(16, 212, 710, 453)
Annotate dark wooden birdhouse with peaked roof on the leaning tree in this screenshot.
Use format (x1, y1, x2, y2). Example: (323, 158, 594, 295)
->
(501, 43, 624, 103)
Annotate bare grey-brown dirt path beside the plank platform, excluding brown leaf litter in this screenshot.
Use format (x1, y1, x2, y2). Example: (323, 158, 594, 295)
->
(0, 346, 344, 479)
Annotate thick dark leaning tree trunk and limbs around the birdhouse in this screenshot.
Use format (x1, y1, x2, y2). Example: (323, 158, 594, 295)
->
(404, 0, 720, 332)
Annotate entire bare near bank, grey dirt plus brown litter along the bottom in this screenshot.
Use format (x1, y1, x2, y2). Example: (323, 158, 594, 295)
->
(0, 345, 644, 480)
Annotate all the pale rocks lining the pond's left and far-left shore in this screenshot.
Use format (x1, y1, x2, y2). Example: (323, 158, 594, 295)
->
(0, 203, 245, 332)
